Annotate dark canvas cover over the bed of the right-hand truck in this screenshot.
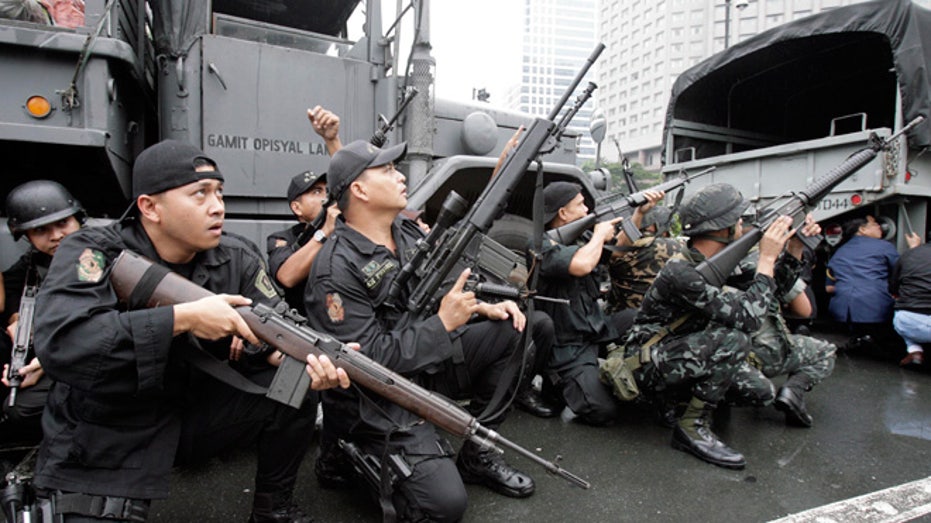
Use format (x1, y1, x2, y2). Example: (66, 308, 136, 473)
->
(663, 0, 931, 162)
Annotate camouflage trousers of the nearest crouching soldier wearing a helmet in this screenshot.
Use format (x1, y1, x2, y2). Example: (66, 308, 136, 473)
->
(635, 324, 752, 403)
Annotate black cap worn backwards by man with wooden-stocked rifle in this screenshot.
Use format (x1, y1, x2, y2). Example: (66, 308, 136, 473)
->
(123, 140, 223, 218)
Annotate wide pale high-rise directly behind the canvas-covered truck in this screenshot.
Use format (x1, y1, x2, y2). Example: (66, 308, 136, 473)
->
(600, 0, 931, 168)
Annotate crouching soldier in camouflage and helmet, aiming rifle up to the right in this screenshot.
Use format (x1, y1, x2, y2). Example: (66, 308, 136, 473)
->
(609, 184, 793, 469)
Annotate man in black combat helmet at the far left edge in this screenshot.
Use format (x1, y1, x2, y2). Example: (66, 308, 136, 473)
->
(0, 180, 86, 443)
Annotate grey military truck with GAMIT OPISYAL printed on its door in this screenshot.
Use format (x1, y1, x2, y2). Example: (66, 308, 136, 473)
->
(0, 0, 595, 266)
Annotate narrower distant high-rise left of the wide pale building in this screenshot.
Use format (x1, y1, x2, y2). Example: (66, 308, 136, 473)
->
(508, 0, 603, 160)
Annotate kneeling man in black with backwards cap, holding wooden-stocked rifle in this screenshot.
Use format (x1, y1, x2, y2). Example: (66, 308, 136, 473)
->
(35, 140, 348, 522)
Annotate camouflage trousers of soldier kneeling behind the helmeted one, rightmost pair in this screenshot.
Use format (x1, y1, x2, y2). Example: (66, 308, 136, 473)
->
(729, 315, 837, 406)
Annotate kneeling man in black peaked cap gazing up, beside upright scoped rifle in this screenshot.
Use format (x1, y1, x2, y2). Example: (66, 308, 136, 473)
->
(306, 140, 552, 521)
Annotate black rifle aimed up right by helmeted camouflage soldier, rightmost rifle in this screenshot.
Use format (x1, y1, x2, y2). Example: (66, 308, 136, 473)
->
(695, 116, 924, 287)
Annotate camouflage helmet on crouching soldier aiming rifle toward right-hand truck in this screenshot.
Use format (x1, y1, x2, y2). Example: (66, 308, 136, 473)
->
(679, 183, 750, 236)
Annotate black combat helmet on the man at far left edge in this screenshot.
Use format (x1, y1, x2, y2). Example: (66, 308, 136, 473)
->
(6, 180, 84, 240)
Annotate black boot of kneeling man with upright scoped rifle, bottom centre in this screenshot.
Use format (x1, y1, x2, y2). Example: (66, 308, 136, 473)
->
(456, 441, 534, 498)
